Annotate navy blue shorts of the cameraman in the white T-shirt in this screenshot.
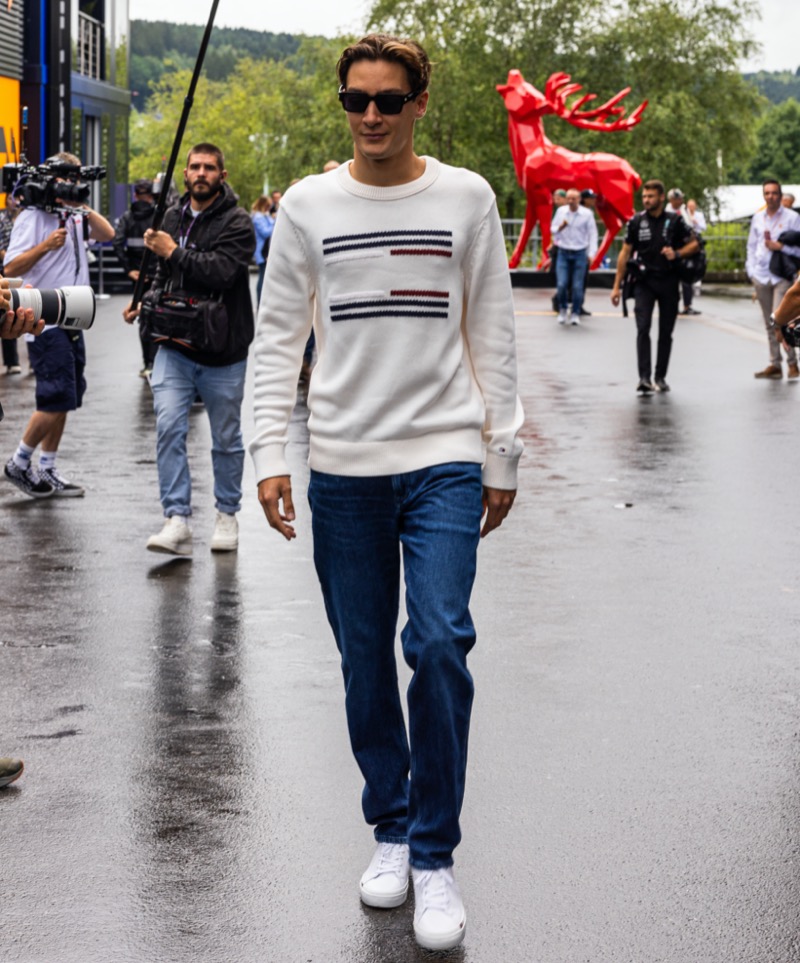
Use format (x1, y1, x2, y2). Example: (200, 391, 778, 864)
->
(28, 328, 86, 411)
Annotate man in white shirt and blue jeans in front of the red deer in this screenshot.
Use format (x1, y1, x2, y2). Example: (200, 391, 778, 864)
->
(550, 187, 597, 325)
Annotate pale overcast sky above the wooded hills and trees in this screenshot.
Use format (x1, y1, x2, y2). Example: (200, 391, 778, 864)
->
(130, 0, 800, 71)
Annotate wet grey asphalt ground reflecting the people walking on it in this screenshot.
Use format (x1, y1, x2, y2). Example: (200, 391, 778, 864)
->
(0, 291, 800, 963)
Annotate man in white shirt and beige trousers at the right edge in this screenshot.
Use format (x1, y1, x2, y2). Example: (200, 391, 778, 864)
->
(745, 180, 800, 381)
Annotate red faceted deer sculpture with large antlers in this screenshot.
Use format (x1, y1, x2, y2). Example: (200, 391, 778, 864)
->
(497, 70, 647, 270)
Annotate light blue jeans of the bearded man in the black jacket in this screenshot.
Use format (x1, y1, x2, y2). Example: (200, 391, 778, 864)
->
(150, 347, 247, 518)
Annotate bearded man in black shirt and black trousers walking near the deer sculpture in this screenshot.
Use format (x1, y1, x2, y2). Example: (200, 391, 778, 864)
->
(611, 180, 699, 395)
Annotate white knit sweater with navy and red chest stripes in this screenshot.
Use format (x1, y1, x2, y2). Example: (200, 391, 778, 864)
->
(250, 157, 523, 489)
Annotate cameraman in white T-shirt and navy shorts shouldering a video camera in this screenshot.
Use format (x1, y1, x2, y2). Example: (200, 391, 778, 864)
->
(4, 152, 114, 498)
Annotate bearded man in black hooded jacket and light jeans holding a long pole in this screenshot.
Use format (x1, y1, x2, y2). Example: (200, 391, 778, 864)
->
(125, 143, 255, 556)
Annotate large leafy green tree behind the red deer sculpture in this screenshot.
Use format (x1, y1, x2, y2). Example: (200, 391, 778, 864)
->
(370, 0, 760, 216)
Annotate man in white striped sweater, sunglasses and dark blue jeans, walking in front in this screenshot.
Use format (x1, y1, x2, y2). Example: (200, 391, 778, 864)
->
(250, 35, 523, 949)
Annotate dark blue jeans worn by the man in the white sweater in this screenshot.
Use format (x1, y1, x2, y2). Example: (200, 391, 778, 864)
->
(308, 463, 482, 869)
